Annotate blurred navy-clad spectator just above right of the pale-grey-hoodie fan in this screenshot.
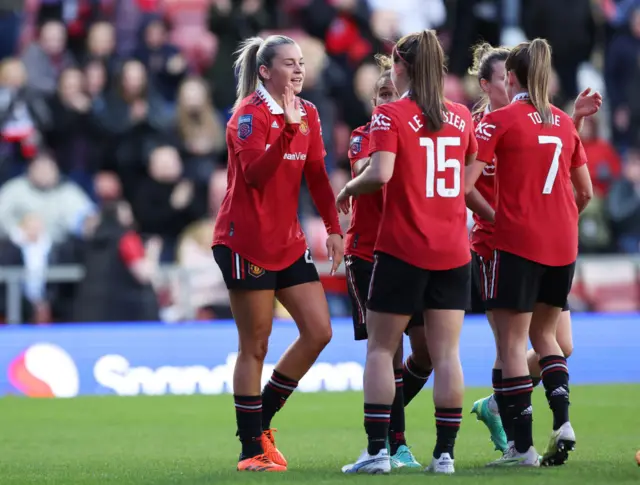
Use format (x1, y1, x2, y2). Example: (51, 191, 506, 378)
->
(44, 68, 102, 194)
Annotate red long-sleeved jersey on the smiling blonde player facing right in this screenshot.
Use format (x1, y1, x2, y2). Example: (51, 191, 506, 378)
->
(213, 86, 342, 271)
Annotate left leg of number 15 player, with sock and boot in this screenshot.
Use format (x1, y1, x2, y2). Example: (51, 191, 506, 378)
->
(342, 310, 410, 474)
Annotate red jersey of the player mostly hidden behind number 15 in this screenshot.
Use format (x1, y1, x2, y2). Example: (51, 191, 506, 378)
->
(344, 123, 382, 261)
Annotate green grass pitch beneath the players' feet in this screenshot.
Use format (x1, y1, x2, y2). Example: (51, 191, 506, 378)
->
(0, 385, 640, 485)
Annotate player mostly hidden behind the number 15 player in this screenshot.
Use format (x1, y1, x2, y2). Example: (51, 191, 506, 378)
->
(344, 56, 431, 468)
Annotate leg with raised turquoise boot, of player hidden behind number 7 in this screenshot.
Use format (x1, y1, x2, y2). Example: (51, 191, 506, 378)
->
(471, 312, 504, 453)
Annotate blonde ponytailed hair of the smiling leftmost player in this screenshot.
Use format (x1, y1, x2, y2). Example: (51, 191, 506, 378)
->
(232, 35, 295, 111)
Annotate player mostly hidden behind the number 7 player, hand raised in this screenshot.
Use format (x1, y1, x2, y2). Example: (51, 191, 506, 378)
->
(470, 43, 602, 458)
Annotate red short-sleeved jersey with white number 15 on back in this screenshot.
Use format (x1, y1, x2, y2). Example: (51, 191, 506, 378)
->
(369, 97, 477, 270)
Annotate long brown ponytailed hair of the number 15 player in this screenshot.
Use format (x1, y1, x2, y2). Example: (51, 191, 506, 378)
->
(394, 30, 447, 132)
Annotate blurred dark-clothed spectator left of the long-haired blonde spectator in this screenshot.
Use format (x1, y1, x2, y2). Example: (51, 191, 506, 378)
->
(94, 60, 174, 200)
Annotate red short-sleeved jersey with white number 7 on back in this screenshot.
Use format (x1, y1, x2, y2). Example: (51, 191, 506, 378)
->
(476, 96, 587, 266)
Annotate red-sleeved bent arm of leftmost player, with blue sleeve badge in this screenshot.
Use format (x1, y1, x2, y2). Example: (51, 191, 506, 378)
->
(234, 105, 300, 188)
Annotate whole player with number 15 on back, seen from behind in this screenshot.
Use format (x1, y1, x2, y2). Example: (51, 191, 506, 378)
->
(337, 30, 476, 473)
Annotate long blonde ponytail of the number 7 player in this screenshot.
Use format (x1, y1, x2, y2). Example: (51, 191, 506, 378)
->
(527, 39, 551, 124)
